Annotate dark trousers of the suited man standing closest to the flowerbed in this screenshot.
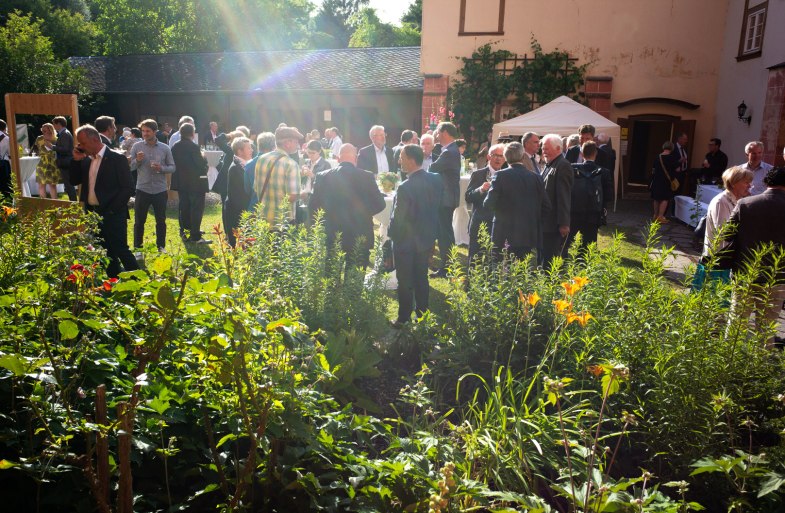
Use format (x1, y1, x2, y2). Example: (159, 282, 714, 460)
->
(393, 244, 431, 322)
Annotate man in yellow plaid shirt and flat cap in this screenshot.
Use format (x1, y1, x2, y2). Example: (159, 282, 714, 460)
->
(251, 126, 303, 225)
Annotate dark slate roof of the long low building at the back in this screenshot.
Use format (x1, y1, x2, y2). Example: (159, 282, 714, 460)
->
(69, 46, 423, 93)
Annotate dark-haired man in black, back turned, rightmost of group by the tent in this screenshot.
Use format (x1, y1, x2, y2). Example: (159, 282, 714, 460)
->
(567, 141, 613, 248)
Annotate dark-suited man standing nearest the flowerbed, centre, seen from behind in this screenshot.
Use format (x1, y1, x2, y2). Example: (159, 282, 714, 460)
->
(387, 144, 442, 327)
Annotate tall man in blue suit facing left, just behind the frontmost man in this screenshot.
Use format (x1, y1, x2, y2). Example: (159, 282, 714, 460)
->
(428, 121, 461, 278)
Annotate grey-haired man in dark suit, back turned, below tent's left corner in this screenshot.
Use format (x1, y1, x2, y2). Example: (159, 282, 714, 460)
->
(484, 142, 550, 259)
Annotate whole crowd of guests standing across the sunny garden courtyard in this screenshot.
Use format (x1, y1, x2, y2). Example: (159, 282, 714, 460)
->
(0, 116, 785, 338)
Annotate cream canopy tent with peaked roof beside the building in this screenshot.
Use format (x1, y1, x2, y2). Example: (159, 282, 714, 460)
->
(493, 96, 621, 210)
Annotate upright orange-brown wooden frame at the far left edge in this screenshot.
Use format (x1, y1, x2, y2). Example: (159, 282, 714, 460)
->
(5, 93, 79, 213)
